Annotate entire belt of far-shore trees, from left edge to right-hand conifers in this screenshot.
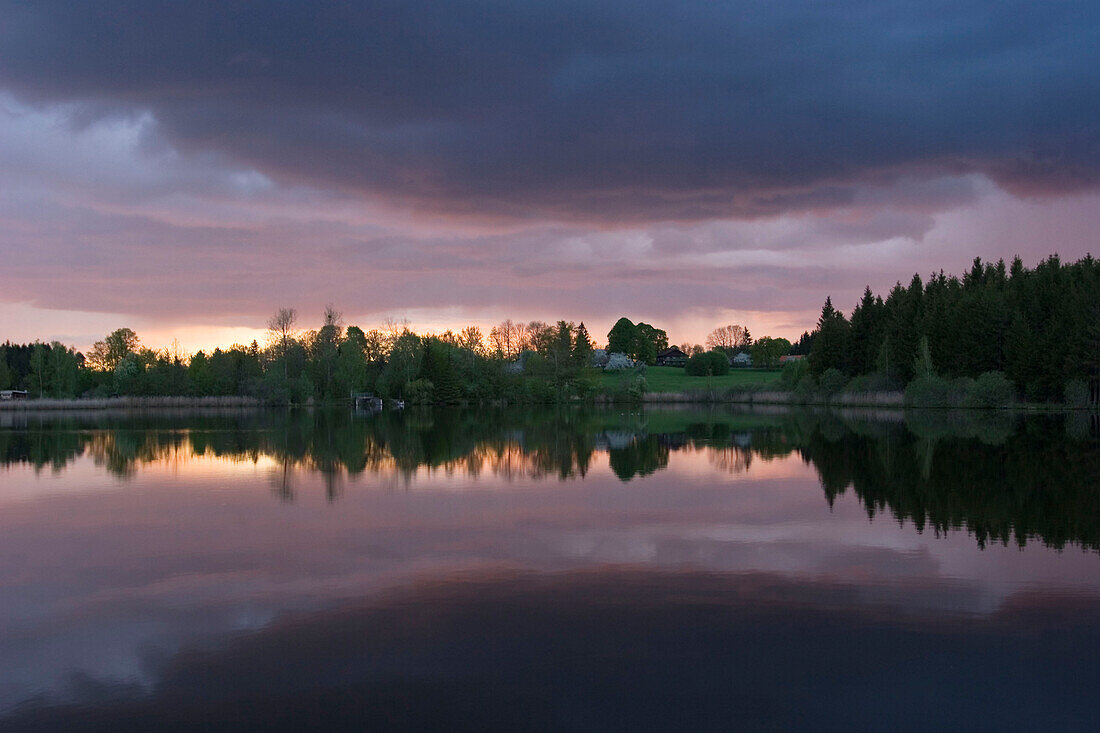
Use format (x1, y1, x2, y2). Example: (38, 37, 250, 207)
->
(0, 250, 1100, 406)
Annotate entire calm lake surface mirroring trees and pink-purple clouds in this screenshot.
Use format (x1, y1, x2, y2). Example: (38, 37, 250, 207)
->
(0, 407, 1100, 731)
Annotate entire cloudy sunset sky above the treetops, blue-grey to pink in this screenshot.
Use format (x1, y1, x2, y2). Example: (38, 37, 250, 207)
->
(0, 0, 1100, 349)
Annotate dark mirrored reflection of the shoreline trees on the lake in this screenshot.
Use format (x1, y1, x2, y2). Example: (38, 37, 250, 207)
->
(0, 408, 1100, 550)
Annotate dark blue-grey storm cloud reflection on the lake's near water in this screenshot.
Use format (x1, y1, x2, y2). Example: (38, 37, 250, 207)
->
(0, 570, 1100, 732)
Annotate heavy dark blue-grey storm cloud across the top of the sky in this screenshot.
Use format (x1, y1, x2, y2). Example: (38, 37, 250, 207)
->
(0, 0, 1100, 222)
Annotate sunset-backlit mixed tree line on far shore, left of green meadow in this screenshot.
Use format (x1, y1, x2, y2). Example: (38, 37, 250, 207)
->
(0, 306, 595, 404)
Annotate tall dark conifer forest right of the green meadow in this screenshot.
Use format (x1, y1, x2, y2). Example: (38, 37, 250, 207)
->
(792, 255, 1100, 401)
